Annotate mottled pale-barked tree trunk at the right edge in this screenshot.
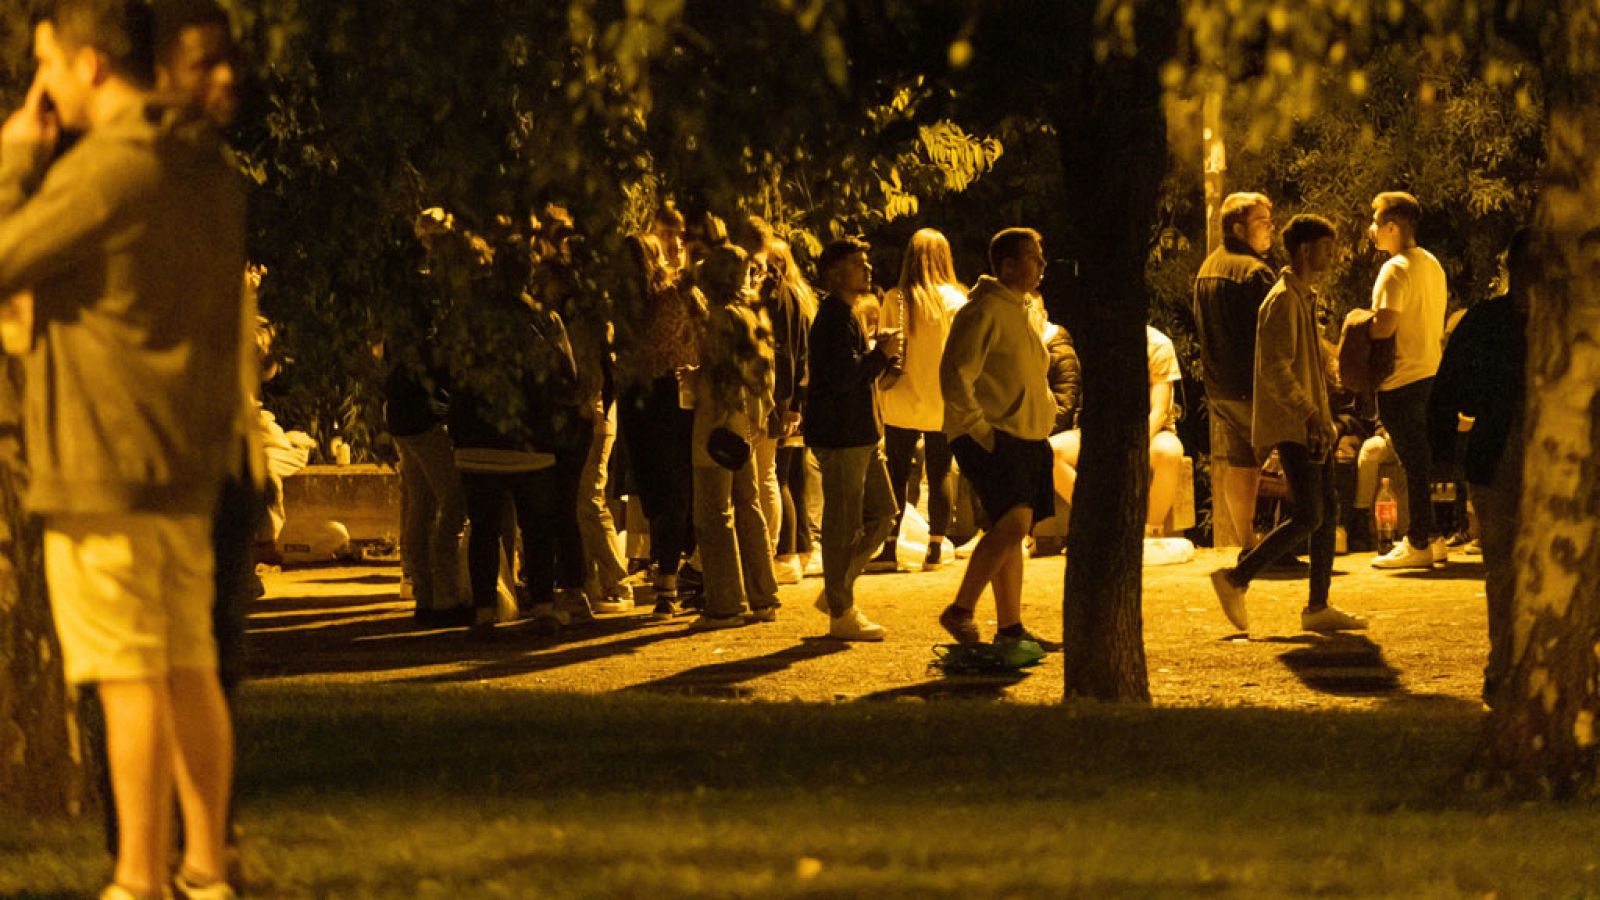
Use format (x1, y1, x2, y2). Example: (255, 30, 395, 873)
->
(1478, 0, 1600, 798)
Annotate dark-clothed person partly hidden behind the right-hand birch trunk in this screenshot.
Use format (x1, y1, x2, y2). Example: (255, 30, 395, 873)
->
(1429, 231, 1533, 706)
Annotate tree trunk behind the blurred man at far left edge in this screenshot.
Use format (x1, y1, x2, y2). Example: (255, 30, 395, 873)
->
(0, 357, 83, 815)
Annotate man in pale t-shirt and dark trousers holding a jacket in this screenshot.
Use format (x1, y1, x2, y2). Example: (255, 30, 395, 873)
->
(1368, 191, 1448, 569)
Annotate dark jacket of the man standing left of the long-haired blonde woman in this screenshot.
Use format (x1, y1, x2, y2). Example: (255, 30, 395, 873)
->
(805, 295, 890, 450)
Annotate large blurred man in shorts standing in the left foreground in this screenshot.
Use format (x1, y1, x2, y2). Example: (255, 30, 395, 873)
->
(0, 0, 245, 898)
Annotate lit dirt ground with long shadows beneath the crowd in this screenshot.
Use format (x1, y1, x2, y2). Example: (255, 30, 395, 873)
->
(248, 538, 1486, 709)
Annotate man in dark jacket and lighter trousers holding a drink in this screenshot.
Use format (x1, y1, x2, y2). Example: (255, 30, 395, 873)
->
(805, 237, 901, 641)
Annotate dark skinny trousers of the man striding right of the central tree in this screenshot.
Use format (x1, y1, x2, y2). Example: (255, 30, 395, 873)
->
(1229, 444, 1339, 610)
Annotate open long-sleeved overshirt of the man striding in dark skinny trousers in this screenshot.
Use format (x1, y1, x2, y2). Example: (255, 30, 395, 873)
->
(1250, 267, 1333, 458)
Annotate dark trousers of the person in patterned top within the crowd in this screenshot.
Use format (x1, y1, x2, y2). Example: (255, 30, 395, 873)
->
(618, 375, 694, 575)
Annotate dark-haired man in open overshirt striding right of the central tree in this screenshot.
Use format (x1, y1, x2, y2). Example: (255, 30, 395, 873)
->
(1211, 216, 1366, 633)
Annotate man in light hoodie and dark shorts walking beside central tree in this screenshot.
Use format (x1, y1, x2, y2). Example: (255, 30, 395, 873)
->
(939, 227, 1056, 663)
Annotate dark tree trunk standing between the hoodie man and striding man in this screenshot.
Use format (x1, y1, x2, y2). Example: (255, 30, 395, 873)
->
(1053, 3, 1178, 701)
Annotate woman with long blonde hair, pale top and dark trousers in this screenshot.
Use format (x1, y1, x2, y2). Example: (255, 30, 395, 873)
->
(874, 227, 966, 570)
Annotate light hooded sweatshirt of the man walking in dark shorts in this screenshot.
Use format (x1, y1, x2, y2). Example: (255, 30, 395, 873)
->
(939, 275, 1056, 447)
